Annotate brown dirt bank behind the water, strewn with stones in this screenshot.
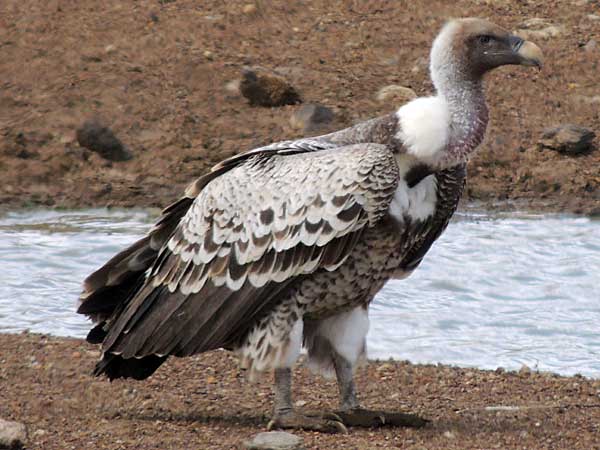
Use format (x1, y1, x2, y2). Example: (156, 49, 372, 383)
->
(0, 0, 600, 212)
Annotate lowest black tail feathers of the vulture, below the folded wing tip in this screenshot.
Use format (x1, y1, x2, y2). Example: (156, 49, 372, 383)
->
(94, 353, 167, 381)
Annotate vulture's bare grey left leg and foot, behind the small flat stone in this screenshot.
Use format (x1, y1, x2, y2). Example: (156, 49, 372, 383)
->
(268, 368, 348, 433)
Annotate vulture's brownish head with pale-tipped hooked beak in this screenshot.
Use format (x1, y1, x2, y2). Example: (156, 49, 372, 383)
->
(430, 18, 543, 87)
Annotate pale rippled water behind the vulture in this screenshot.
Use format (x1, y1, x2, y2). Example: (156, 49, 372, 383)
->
(0, 209, 600, 378)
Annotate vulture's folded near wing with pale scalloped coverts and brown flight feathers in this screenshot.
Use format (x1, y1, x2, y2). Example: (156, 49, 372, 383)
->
(97, 144, 398, 358)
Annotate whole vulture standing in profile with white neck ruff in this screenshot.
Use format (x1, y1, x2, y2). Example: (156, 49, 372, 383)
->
(78, 18, 542, 432)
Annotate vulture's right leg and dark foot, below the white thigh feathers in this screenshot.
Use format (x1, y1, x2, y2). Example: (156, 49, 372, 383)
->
(333, 351, 427, 428)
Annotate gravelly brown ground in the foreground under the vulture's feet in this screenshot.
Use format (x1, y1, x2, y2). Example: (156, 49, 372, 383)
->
(0, 333, 600, 450)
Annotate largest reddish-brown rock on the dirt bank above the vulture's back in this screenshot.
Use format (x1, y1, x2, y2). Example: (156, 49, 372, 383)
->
(240, 68, 302, 106)
